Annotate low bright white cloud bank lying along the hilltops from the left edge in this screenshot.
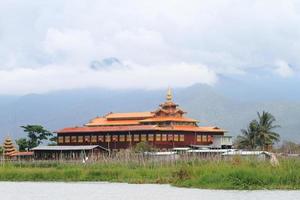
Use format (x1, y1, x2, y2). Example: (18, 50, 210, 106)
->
(0, 63, 217, 94)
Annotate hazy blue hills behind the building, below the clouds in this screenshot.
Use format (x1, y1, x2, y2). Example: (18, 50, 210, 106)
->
(0, 85, 300, 142)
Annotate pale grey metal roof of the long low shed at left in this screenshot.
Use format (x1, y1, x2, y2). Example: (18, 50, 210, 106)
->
(31, 145, 103, 151)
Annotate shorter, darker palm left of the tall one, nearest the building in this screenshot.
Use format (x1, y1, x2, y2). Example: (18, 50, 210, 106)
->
(237, 120, 258, 149)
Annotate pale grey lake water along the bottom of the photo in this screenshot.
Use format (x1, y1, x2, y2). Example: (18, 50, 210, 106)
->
(0, 182, 300, 200)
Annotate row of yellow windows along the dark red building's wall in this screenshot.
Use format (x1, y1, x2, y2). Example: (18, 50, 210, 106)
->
(58, 134, 212, 143)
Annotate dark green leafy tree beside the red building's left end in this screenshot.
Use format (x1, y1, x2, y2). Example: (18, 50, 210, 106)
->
(21, 125, 52, 149)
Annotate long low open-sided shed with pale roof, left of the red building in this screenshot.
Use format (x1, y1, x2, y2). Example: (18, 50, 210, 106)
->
(32, 145, 109, 160)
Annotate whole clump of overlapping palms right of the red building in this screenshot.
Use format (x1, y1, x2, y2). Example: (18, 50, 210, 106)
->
(236, 111, 280, 150)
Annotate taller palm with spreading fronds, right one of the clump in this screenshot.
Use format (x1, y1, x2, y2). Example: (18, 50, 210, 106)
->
(257, 111, 280, 150)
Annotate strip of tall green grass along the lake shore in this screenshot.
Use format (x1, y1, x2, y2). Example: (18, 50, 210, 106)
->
(0, 158, 300, 190)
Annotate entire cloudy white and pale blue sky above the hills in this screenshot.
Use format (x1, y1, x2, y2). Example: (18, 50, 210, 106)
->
(0, 0, 300, 95)
